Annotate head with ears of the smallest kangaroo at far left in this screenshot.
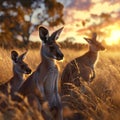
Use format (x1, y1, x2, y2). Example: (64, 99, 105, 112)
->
(11, 51, 31, 74)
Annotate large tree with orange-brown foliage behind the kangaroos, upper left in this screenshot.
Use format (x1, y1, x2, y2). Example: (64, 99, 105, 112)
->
(0, 0, 64, 46)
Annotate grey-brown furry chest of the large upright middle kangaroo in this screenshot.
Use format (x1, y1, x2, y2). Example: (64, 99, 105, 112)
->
(36, 61, 58, 103)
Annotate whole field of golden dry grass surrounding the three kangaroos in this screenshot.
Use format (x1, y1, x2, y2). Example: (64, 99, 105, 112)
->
(0, 46, 120, 120)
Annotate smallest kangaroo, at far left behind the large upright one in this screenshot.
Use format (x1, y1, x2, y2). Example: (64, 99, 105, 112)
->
(0, 51, 31, 96)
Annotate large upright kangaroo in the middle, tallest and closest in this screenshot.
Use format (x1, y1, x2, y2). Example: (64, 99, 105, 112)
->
(18, 26, 64, 120)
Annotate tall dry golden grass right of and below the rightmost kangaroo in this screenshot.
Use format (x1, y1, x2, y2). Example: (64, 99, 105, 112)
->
(62, 47, 120, 120)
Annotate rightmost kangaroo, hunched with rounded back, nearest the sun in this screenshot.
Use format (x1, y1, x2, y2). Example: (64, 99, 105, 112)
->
(61, 33, 105, 94)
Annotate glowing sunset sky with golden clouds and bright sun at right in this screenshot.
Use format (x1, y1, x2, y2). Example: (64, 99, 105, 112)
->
(30, 0, 120, 45)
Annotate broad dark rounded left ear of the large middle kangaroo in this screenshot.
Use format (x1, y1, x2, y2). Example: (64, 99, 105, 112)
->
(39, 26, 49, 43)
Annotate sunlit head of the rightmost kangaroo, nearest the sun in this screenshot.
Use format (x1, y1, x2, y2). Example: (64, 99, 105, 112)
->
(84, 33, 105, 52)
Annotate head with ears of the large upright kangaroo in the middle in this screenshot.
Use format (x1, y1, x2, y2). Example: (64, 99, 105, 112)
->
(39, 26, 64, 60)
